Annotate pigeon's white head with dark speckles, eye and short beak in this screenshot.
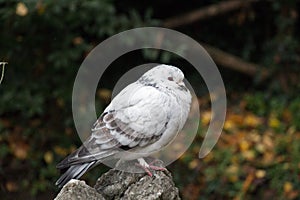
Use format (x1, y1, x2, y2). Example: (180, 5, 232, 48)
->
(139, 65, 187, 90)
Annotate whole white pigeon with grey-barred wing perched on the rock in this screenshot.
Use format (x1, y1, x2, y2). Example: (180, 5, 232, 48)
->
(56, 65, 192, 187)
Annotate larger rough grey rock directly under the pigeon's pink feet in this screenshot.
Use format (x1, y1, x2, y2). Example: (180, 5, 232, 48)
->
(94, 170, 180, 200)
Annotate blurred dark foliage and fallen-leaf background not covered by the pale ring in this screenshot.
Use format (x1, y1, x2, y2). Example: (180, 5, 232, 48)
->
(0, 0, 300, 200)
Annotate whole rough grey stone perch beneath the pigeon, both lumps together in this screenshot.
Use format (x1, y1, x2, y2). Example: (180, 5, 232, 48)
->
(56, 160, 180, 200)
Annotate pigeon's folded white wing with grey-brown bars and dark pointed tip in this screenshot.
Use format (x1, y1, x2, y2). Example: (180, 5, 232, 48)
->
(57, 85, 169, 169)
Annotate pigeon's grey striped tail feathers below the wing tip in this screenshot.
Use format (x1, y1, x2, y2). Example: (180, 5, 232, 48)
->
(55, 161, 96, 188)
